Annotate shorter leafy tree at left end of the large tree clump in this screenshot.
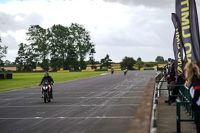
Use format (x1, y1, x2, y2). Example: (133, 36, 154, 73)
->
(15, 43, 37, 71)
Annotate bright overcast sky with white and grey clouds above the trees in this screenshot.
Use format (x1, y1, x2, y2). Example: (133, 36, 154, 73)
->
(0, 0, 200, 62)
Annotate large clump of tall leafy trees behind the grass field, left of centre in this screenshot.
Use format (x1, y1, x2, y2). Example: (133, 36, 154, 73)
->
(15, 23, 94, 71)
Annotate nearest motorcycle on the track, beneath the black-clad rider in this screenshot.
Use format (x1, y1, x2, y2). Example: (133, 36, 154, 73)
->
(41, 81, 52, 103)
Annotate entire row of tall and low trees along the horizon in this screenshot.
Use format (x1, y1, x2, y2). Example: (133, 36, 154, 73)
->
(0, 23, 165, 71)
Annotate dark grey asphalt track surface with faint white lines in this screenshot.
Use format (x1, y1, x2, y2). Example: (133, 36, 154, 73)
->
(0, 71, 156, 133)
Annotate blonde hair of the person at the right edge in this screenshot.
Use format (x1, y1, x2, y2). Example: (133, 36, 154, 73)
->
(184, 62, 200, 84)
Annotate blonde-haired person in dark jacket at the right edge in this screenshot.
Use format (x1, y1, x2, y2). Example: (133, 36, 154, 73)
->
(184, 62, 200, 133)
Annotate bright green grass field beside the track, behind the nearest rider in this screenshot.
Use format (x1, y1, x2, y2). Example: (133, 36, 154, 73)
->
(0, 71, 108, 92)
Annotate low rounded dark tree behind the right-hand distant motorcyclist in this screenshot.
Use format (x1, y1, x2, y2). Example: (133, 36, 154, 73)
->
(120, 56, 136, 70)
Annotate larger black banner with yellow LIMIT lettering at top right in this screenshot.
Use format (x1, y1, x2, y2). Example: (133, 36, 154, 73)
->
(176, 0, 200, 67)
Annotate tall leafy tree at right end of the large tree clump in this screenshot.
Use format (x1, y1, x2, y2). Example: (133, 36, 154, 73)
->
(69, 23, 94, 69)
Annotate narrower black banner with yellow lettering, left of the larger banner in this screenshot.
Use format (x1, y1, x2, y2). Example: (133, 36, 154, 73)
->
(172, 13, 184, 77)
